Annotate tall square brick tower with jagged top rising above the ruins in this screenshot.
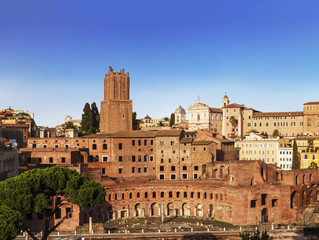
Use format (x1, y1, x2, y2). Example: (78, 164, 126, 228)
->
(100, 67, 132, 133)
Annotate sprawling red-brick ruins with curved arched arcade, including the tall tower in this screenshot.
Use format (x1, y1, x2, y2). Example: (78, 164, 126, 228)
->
(20, 68, 319, 231)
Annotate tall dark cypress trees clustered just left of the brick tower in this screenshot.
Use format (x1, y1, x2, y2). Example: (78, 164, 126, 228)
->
(80, 102, 100, 135)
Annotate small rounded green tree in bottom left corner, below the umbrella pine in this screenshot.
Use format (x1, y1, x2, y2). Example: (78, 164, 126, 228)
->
(0, 205, 22, 240)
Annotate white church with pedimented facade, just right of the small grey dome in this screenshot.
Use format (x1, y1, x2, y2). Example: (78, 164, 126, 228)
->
(188, 101, 223, 133)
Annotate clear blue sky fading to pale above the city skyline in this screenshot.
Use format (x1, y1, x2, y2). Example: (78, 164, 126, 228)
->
(0, 0, 319, 126)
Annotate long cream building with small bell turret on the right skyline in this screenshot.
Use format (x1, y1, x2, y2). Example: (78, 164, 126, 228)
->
(222, 95, 319, 138)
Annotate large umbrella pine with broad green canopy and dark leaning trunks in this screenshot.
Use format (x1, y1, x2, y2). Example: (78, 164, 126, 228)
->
(0, 166, 105, 240)
